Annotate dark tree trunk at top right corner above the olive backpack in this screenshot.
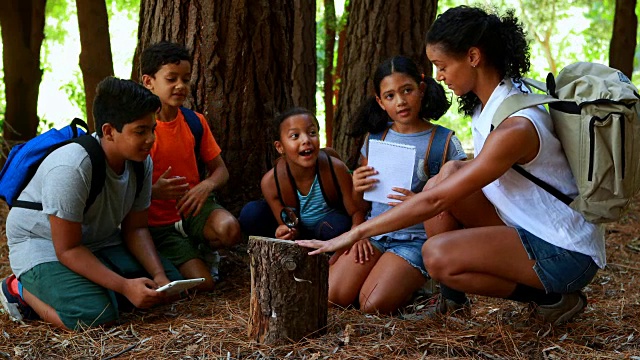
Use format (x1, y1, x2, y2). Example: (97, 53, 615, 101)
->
(609, 0, 638, 79)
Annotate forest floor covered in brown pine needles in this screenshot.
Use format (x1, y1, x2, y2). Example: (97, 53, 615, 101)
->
(0, 199, 640, 360)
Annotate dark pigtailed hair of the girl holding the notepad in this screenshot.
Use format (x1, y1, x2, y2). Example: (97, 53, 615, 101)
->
(349, 56, 451, 137)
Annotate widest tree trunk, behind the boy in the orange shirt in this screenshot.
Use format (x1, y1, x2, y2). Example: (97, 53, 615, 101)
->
(133, 0, 294, 214)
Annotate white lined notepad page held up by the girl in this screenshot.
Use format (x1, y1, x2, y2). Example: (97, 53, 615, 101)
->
(364, 140, 416, 203)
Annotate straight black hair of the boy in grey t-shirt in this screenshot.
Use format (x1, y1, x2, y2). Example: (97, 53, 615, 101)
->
(93, 76, 162, 137)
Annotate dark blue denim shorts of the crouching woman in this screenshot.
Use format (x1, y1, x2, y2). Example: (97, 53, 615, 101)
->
(516, 228, 598, 294)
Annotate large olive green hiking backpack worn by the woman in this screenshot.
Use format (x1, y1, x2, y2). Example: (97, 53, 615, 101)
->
(492, 62, 640, 223)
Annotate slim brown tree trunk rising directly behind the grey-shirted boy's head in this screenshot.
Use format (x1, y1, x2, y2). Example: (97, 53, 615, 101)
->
(76, 0, 113, 132)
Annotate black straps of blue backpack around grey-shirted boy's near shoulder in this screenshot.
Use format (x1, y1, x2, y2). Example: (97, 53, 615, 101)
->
(13, 134, 107, 213)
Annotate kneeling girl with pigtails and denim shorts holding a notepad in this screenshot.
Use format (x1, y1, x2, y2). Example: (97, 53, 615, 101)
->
(329, 56, 466, 313)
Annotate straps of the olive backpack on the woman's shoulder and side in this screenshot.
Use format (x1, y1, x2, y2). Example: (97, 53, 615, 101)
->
(491, 93, 576, 205)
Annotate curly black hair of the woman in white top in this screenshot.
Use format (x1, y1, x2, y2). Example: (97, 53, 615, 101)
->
(427, 6, 531, 115)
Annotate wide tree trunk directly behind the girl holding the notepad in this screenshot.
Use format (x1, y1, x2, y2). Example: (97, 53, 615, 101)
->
(333, 0, 437, 168)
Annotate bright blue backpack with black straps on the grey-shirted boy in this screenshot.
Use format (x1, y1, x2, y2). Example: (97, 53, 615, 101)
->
(0, 118, 144, 212)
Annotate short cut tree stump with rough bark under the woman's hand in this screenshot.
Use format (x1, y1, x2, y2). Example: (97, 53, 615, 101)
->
(248, 236, 329, 344)
